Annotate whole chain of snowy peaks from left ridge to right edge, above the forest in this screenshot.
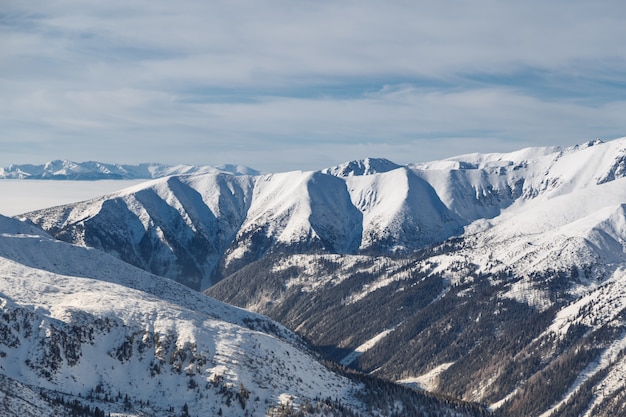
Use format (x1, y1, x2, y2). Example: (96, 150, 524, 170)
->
(20, 139, 626, 289)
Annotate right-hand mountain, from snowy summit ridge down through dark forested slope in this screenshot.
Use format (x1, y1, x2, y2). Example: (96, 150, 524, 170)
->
(208, 139, 626, 417)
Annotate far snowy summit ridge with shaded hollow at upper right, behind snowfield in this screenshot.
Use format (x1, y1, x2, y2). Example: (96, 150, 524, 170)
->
(410, 139, 626, 221)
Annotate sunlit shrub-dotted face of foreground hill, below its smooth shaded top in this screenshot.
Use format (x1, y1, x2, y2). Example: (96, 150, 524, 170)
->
(1, 272, 356, 415)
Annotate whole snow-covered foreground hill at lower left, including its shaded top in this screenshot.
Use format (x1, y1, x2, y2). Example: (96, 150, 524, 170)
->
(0, 217, 481, 417)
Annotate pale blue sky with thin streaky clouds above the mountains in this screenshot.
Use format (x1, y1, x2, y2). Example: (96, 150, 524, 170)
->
(0, 0, 626, 172)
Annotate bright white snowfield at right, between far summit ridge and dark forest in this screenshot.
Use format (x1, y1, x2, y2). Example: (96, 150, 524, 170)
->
(420, 161, 626, 294)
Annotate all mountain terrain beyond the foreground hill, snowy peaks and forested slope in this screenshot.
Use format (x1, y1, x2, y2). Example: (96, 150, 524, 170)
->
(18, 138, 626, 417)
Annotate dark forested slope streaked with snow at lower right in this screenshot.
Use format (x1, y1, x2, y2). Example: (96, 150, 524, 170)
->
(208, 248, 626, 416)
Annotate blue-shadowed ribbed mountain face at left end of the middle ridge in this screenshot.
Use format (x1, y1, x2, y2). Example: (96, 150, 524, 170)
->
(20, 174, 252, 289)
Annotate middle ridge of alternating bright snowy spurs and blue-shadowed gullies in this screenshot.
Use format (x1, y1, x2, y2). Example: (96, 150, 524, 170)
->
(20, 167, 465, 289)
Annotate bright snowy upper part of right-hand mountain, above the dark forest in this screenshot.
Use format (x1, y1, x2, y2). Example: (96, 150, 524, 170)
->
(415, 139, 626, 274)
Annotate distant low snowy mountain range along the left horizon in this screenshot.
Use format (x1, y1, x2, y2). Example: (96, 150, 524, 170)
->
(0, 160, 259, 180)
